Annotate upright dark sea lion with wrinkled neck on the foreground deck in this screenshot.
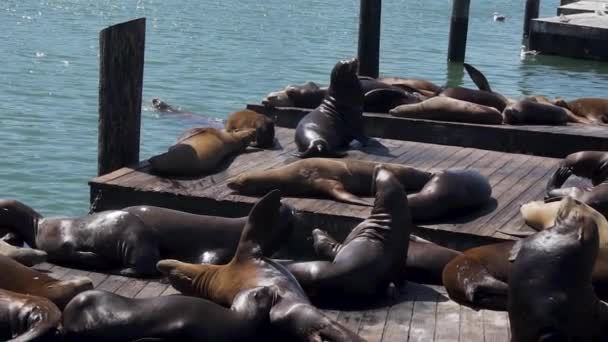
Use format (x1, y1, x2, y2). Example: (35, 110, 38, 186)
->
(287, 165, 413, 296)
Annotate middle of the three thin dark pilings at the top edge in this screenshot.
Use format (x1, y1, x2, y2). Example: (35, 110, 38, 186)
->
(448, 0, 471, 62)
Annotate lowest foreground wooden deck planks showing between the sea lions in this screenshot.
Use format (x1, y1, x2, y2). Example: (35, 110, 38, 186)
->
(34, 263, 510, 342)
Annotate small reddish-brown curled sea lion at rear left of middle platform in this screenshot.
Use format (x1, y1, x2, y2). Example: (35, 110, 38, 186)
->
(225, 109, 274, 148)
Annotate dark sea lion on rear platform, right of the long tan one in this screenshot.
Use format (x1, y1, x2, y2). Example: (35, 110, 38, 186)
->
(502, 99, 569, 125)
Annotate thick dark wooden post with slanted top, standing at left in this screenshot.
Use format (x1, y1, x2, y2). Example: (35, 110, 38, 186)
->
(97, 18, 146, 175)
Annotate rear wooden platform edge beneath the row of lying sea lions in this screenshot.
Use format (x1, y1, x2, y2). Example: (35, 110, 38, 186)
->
(247, 103, 608, 158)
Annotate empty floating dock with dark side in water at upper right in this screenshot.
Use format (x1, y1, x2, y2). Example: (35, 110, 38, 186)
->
(528, 13, 608, 61)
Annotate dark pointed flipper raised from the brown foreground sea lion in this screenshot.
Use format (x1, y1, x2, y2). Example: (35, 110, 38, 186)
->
(235, 190, 283, 259)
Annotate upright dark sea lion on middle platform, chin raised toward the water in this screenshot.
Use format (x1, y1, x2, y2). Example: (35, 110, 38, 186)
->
(295, 59, 369, 158)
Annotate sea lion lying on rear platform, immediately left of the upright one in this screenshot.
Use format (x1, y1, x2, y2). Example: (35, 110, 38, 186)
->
(262, 81, 325, 108)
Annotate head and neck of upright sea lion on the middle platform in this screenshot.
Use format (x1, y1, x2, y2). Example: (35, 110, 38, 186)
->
(329, 58, 363, 107)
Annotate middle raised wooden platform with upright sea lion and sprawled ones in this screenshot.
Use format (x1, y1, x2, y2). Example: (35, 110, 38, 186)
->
(89, 127, 560, 254)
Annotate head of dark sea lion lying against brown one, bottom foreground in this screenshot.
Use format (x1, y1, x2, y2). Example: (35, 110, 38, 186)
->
(230, 286, 276, 321)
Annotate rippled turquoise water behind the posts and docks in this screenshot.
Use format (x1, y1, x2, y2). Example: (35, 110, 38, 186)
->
(0, 0, 608, 215)
